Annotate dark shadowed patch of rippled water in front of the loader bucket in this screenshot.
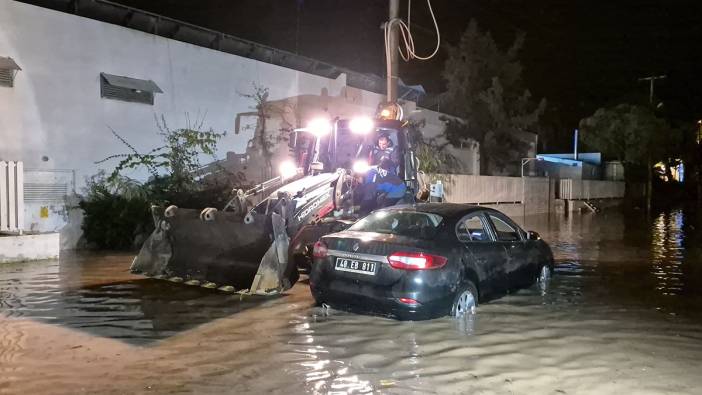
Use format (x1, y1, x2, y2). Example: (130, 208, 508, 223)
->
(0, 260, 270, 344)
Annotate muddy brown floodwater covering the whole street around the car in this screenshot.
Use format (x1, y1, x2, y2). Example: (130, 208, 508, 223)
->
(0, 210, 702, 394)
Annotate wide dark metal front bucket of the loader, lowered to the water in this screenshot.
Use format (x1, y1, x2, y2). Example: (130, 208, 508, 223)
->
(131, 209, 297, 293)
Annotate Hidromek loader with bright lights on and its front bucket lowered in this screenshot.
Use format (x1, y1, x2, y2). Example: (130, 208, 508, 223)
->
(131, 104, 419, 295)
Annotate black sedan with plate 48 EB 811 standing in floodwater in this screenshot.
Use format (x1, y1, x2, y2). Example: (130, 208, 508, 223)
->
(310, 203, 553, 320)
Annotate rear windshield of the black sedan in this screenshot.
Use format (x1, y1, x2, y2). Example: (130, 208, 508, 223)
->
(349, 210, 443, 240)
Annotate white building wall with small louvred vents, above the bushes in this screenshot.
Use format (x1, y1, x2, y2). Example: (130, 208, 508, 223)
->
(0, 0, 390, 184)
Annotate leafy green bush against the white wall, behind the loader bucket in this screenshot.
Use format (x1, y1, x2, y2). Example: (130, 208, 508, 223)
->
(79, 117, 238, 249)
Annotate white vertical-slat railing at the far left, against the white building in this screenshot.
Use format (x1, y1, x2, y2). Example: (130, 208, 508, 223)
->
(0, 161, 24, 233)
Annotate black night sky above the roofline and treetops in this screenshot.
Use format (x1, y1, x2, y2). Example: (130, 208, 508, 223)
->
(62, 0, 702, 145)
